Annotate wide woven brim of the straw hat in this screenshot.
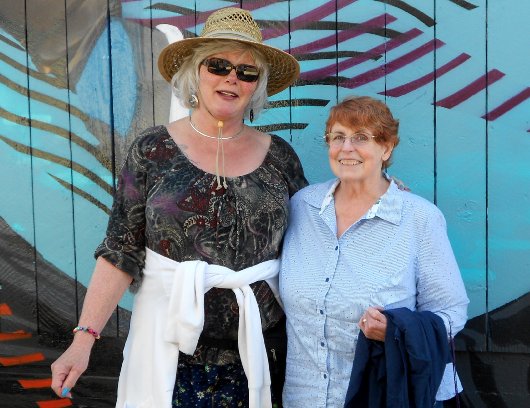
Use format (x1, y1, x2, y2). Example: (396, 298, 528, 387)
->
(158, 37, 300, 96)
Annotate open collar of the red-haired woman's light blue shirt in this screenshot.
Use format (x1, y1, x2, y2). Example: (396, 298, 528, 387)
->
(306, 179, 403, 225)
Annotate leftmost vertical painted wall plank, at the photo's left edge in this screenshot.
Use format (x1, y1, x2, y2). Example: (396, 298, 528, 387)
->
(0, 2, 37, 332)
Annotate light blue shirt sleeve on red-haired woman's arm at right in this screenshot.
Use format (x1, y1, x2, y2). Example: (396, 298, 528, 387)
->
(416, 207, 469, 336)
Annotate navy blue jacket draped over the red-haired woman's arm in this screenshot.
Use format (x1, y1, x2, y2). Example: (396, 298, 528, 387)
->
(344, 308, 451, 408)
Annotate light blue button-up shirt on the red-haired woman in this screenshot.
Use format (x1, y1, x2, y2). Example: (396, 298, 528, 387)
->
(280, 180, 469, 408)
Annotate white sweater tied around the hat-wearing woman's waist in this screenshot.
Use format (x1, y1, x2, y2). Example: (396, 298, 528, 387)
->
(116, 248, 279, 408)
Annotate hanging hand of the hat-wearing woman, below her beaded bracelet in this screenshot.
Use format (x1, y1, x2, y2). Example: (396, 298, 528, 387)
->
(51, 332, 95, 398)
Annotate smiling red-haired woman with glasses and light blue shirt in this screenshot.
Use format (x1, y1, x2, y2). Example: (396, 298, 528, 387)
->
(280, 97, 468, 408)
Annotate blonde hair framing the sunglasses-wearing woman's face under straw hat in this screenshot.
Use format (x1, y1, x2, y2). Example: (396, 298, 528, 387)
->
(171, 40, 269, 119)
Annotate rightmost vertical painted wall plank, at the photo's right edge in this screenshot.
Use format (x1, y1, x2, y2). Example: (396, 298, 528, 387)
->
(487, 0, 530, 353)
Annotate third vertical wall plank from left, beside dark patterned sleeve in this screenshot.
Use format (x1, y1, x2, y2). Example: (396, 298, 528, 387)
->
(61, 0, 117, 336)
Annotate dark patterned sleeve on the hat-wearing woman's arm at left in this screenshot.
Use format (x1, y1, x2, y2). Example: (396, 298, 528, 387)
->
(94, 138, 147, 280)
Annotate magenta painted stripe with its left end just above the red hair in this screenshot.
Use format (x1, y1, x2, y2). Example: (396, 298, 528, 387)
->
(340, 40, 445, 88)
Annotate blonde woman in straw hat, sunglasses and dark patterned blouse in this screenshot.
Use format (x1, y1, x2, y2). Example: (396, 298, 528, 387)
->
(52, 8, 307, 408)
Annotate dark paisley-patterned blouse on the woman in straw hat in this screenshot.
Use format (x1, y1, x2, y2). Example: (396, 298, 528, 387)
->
(95, 126, 307, 364)
